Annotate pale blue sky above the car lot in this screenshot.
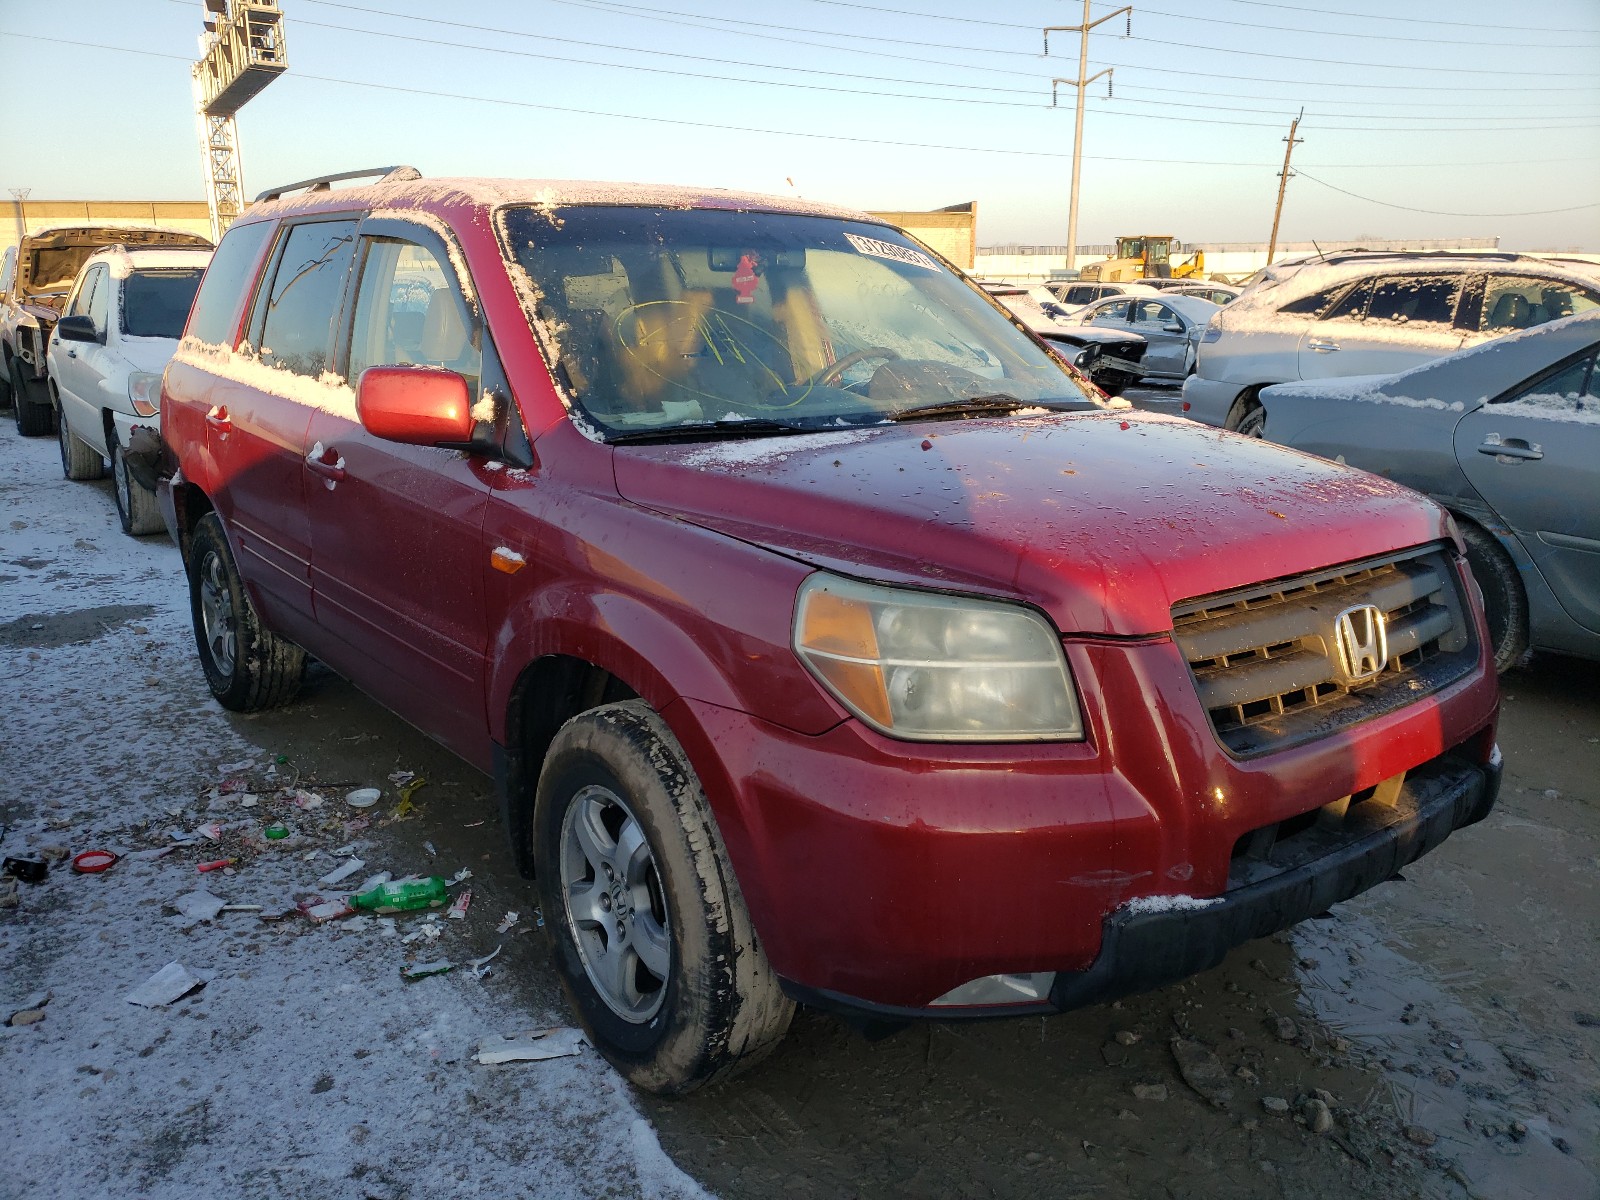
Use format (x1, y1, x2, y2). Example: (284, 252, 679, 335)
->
(0, 0, 1600, 251)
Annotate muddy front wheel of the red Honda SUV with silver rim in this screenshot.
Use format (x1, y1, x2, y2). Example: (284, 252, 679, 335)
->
(533, 701, 794, 1094)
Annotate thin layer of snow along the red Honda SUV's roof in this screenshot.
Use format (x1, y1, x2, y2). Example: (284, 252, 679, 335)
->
(245, 178, 883, 224)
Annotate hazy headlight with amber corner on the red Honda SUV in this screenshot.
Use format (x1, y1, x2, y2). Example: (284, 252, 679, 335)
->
(795, 573, 1083, 742)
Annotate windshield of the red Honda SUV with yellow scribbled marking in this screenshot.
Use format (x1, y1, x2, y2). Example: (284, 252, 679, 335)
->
(502, 206, 1098, 435)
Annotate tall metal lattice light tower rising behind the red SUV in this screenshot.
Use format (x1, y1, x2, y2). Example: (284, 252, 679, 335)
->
(194, 0, 290, 242)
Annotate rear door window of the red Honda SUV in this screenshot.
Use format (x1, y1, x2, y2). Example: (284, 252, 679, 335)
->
(250, 219, 355, 379)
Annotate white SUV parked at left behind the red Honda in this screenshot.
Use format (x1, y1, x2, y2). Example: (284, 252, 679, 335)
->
(46, 246, 211, 536)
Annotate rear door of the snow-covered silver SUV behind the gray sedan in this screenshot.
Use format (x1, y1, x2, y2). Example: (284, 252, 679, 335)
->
(1299, 274, 1466, 379)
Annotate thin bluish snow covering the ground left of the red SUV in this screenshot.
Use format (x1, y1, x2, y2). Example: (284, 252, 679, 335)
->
(0, 419, 704, 1200)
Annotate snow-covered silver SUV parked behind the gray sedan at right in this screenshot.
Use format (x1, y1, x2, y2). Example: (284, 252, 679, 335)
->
(1184, 251, 1600, 437)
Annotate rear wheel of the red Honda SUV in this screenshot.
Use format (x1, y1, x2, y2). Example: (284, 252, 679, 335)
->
(189, 512, 306, 712)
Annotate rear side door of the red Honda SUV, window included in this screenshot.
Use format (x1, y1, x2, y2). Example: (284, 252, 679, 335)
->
(206, 216, 357, 633)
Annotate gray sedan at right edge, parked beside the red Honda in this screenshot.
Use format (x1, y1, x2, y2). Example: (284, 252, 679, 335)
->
(1261, 312, 1600, 670)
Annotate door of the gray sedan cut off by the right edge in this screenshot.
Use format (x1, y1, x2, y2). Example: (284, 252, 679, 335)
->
(1456, 347, 1600, 632)
